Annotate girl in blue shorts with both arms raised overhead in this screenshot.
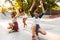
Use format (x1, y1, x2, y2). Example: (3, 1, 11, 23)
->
(32, 1, 46, 40)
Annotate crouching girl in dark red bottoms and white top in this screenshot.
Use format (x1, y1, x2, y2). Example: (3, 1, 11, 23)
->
(9, 12, 18, 32)
